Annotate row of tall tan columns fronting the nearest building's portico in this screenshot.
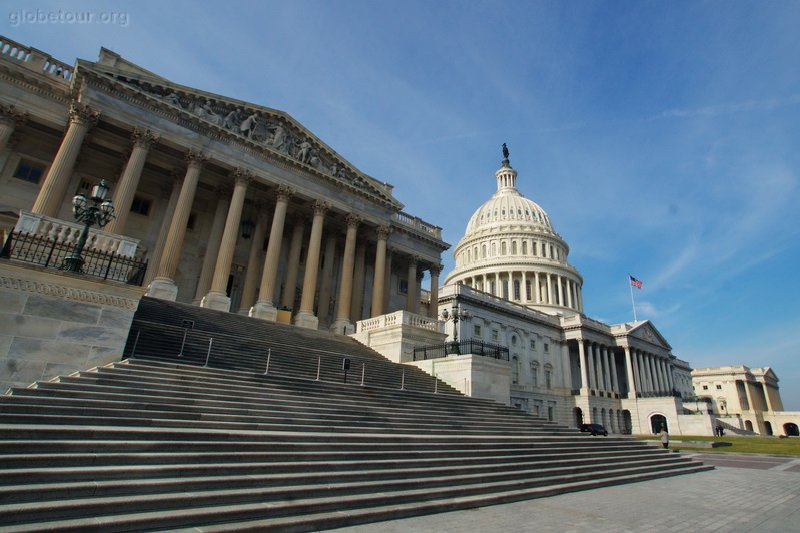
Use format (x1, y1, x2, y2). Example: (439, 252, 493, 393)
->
(26, 102, 439, 331)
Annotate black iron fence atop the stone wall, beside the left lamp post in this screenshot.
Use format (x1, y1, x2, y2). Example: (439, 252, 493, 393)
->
(0, 231, 147, 286)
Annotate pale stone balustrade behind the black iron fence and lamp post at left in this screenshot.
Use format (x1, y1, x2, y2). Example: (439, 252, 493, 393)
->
(14, 210, 139, 257)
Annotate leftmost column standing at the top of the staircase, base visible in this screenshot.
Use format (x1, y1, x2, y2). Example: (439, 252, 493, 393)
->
(147, 150, 206, 302)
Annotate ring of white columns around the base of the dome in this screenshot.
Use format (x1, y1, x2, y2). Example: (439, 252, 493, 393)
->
(464, 270, 583, 312)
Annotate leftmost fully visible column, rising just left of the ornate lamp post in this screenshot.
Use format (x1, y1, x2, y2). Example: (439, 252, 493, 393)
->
(31, 101, 100, 217)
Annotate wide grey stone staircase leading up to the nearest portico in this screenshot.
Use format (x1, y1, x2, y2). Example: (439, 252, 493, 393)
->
(0, 300, 708, 531)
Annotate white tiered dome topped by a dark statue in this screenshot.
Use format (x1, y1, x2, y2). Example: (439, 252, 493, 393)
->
(445, 150, 583, 314)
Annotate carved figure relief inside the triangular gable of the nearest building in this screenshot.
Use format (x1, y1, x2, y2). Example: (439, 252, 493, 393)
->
(76, 63, 396, 209)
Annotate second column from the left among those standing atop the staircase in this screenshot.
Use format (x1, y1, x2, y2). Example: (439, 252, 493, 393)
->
(200, 168, 253, 312)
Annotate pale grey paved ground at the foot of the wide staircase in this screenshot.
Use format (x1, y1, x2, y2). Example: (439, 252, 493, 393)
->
(337, 454, 800, 533)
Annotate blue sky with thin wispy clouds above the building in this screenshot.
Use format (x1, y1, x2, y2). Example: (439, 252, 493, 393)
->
(6, 0, 800, 410)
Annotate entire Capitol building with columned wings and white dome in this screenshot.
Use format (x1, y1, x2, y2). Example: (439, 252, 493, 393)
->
(0, 37, 800, 435)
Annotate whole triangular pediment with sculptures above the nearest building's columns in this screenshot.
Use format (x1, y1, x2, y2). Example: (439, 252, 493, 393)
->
(76, 60, 403, 211)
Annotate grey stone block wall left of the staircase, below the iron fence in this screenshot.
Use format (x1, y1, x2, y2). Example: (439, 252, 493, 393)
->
(0, 261, 144, 392)
